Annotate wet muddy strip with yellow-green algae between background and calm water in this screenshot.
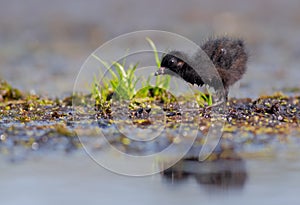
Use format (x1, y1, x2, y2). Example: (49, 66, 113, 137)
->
(0, 84, 300, 163)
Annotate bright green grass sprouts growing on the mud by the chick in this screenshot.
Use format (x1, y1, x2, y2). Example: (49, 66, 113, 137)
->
(91, 37, 212, 109)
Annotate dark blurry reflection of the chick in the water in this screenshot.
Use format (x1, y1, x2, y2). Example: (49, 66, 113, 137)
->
(161, 156, 247, 191)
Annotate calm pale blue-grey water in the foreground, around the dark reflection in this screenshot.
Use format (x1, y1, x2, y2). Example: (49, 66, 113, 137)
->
(0, 153, 300, 205)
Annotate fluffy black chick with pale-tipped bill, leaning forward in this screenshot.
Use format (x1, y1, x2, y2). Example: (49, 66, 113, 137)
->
(155, 37, 248, 100)
